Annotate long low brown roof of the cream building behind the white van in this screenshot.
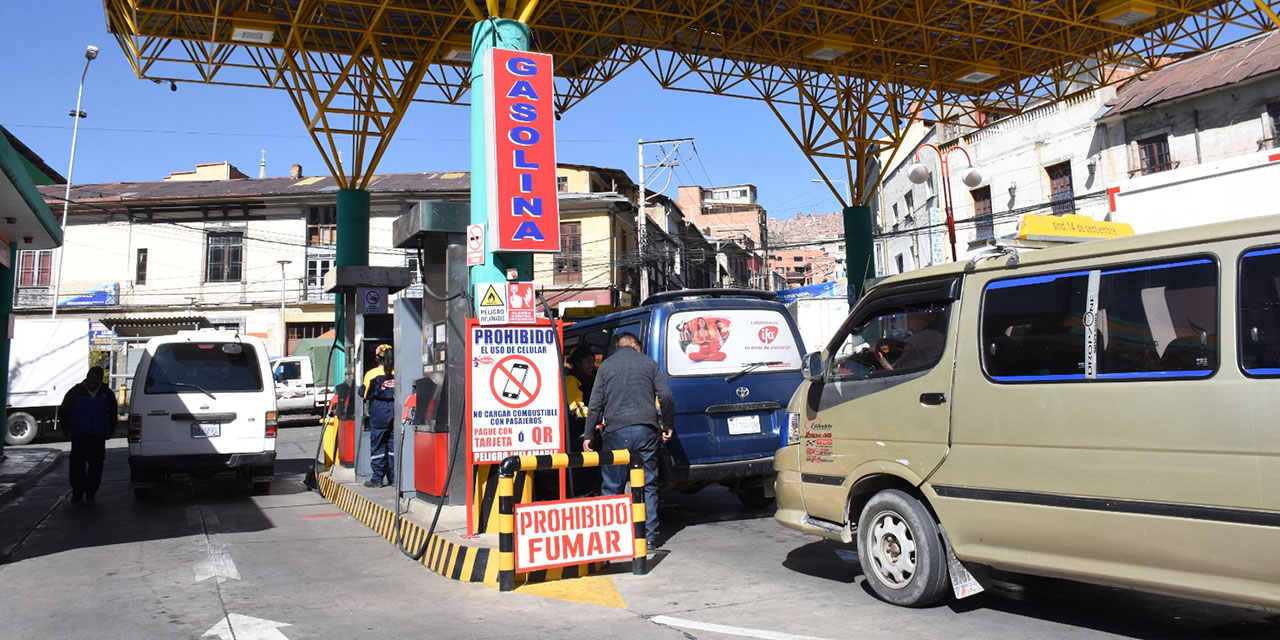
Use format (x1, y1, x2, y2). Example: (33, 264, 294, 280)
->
(40, 172, 471, 202)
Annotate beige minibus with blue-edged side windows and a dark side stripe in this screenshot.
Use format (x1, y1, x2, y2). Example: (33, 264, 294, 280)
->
(776, 216, 1280, 608)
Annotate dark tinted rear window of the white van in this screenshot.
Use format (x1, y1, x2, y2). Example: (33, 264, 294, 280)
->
(143, 342, 262, 393)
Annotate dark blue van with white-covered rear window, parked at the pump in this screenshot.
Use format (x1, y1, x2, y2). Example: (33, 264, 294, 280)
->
(564, 289, 804, 508)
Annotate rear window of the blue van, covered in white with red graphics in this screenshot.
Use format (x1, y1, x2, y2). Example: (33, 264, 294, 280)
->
(667, 308, 800, 375)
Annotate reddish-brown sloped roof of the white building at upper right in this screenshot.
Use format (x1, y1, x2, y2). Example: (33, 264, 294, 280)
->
(1106, 32, 1280, 116)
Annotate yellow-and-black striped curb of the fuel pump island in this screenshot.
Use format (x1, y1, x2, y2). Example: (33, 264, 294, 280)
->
(319, 474, 603, 586)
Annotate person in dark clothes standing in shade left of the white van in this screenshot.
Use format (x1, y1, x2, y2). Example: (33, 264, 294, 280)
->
(58, 366, 115, 502)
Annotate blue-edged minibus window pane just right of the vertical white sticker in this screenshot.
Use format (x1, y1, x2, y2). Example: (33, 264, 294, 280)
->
(1097, 259, 1217, 379)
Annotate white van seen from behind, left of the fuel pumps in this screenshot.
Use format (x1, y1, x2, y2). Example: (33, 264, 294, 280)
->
(129, 330, 276, 498)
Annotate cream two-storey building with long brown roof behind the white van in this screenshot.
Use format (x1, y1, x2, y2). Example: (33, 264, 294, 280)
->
(27, 165, 468, 353)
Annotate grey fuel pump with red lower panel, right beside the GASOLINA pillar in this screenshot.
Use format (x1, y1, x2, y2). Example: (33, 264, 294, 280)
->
(392, 201, 471, 504)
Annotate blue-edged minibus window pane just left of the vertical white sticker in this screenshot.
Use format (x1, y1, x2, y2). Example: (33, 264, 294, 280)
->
(982, 271, 1089, 383)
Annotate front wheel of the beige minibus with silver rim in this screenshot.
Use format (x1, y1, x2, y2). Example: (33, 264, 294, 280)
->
(858, 489, 947, 607)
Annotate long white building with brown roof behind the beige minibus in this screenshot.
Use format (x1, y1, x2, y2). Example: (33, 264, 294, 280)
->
(878, 33, 1280, 274)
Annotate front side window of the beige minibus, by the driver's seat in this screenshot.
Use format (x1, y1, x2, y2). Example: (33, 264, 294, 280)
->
(832, 303, 950, 378)
